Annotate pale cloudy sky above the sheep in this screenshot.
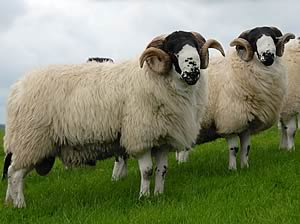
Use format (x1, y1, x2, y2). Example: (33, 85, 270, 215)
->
(0, 0, 300, 124)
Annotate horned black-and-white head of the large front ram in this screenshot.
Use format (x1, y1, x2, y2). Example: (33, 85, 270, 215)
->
(140, 31, 225, 85)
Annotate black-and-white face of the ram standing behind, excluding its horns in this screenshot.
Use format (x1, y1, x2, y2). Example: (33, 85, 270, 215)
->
(237, 27, 282, 66)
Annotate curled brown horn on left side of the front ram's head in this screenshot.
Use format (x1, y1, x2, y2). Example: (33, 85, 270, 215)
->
(140, 47, 172, 74)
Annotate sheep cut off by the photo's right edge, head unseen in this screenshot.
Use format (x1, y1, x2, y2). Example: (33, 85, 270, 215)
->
(279, 37, 300, 151)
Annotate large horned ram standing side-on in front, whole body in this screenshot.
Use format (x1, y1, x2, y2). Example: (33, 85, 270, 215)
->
(3, 31, 224, 208)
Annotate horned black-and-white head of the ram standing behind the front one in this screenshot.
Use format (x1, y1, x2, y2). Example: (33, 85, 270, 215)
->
(230, 27, 295, 66)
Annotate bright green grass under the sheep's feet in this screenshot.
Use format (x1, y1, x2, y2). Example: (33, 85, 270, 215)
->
(0, 128, 300, 224)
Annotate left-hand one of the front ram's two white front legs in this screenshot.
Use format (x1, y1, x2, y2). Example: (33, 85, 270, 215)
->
(137, 150, 153, 198)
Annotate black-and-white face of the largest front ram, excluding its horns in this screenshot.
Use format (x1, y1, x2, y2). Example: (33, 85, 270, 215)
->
(162, 31, 201, 85)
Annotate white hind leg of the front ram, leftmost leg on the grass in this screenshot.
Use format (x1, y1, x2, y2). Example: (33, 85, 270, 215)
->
(5, 165, 32, 208)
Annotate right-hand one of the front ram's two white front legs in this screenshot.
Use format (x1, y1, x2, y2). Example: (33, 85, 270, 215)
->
(154, 149, 168, 195)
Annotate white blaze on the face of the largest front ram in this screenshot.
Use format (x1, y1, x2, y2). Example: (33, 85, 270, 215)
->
(177, 44, 201, 73)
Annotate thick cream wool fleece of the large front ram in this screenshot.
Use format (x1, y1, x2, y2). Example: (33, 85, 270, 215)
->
(4, 59, 207, 169)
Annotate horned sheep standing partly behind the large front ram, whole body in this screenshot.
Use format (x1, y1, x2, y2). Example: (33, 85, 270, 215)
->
(175, 27, 295, 170)
